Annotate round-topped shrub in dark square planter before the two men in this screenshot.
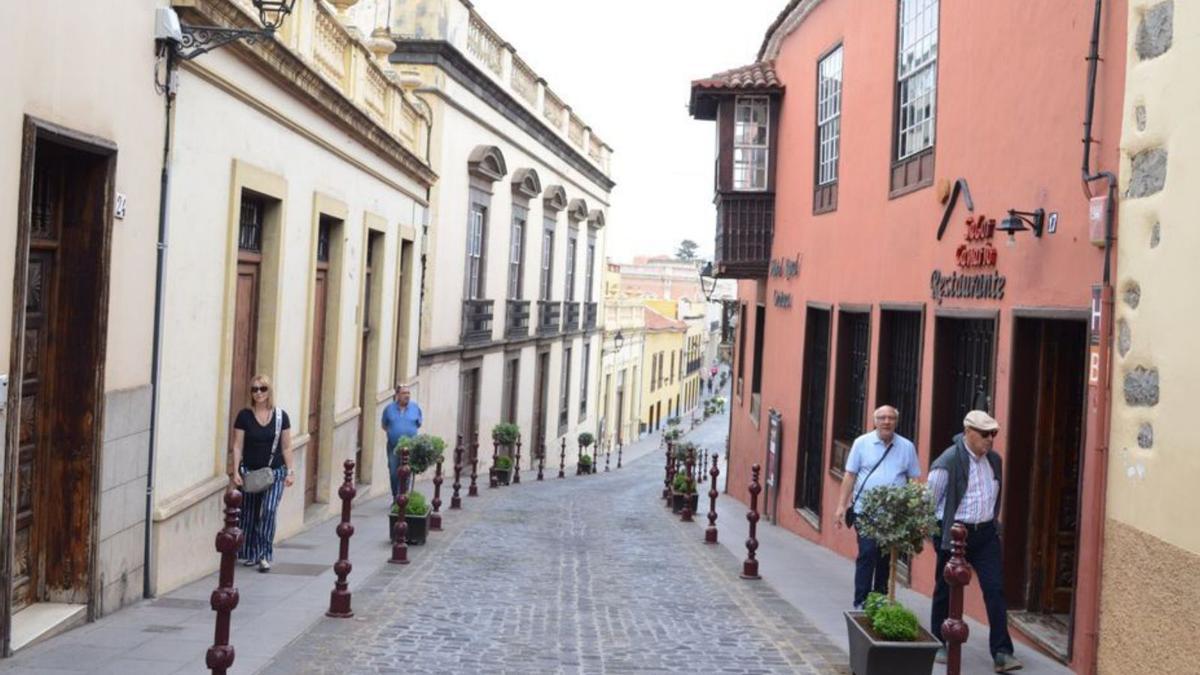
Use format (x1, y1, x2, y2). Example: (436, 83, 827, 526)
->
(844, 483, 942, 675)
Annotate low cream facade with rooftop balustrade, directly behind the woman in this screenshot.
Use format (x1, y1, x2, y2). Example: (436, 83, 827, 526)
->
(150, 0, 436, 593)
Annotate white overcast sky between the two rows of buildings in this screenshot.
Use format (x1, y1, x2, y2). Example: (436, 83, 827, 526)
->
(473, 0, 787, 262)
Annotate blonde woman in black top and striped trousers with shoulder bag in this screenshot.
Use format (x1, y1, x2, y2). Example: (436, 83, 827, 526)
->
(233, 375, 295, 572)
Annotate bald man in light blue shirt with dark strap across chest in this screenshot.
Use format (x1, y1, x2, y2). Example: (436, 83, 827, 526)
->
(835, 406, 920, 608)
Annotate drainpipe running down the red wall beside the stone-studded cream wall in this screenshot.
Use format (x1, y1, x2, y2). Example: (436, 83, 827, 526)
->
(1080, 0, 1117, 673)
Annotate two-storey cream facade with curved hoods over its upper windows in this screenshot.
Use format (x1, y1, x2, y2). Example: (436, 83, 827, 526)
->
(391, 0, 613, 470)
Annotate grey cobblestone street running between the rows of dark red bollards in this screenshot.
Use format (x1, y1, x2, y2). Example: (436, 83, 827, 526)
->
(266, 416, 845, 674)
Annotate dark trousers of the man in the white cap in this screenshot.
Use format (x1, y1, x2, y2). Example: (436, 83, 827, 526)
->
(929, 524, 1013, 656)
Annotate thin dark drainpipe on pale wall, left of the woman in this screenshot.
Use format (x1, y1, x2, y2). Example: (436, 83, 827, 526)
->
(142, 47, 175, 598)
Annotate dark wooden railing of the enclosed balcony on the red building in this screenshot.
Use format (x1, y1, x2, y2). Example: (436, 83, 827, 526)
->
(714, 192, 775, 279)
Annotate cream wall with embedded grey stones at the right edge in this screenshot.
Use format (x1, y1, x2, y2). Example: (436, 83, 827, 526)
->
(1097, 0, 1200, 673)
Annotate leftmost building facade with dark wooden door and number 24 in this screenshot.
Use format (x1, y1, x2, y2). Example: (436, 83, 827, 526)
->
(0, 1, 171, 655)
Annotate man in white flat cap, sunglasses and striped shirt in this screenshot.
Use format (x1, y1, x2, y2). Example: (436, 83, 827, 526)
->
(929, 410, 1021, 673)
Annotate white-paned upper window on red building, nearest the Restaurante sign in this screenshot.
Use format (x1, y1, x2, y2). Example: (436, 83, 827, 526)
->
(895, 0, 938, 160)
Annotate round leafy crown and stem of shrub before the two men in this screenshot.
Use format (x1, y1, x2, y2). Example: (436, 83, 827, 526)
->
(854, 483, 937, 602)
